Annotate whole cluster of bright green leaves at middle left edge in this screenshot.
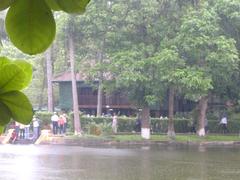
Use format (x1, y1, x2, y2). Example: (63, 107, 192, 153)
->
(0, 57, 33, 127)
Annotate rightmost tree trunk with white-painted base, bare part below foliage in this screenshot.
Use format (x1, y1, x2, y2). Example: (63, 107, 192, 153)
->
(198, 96, 208, 136)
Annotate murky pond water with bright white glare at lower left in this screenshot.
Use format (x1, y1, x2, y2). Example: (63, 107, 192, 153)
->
(0, 145, 240, 180)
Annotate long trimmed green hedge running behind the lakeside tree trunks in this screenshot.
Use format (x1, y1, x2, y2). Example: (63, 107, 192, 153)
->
(36, 112, 240, 133)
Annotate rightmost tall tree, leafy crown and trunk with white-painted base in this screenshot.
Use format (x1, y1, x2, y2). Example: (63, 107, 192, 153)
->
(177, 3, 239, 136)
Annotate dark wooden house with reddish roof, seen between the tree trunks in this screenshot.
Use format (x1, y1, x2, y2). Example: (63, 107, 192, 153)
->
(53, 72, 194, 117)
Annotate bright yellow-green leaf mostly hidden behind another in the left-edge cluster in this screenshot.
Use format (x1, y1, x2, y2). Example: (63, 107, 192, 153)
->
(13, 60, 32, 85)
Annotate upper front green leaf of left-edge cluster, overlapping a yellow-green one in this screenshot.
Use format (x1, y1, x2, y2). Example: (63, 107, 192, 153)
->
(0, 64, 27, 93)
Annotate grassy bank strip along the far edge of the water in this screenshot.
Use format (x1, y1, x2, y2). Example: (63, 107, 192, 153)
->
(0, 129, 240, 147)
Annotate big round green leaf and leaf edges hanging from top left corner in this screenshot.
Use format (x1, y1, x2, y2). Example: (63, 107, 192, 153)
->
(0, 0, 90, 55)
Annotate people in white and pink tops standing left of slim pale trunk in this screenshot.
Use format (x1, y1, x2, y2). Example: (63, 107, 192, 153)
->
(51, 112, 67, 135)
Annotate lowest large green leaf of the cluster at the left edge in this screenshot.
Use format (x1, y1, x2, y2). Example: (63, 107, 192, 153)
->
(0, 91, 33, 124)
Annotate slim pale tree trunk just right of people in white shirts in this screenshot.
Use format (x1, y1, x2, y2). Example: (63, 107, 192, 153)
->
(68, 32, 81, 135)
